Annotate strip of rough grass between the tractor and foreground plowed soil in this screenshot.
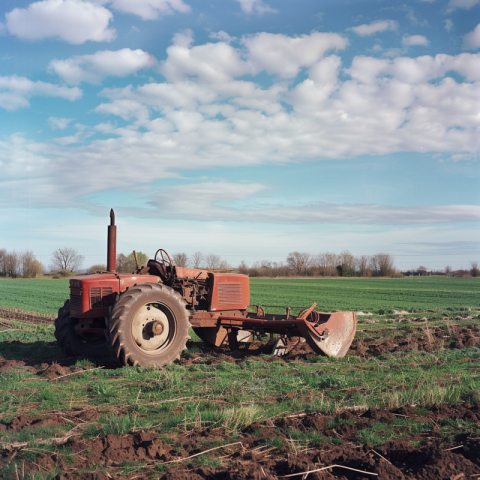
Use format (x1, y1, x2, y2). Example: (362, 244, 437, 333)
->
(0, 316, 480, 441)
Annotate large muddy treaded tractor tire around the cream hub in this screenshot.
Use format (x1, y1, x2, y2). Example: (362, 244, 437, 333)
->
(108, 283, 190, 367)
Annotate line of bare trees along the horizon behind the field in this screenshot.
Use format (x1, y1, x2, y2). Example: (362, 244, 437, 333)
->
(0, 247, 480, 278)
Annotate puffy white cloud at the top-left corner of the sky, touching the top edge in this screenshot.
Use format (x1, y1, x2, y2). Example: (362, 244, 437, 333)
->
(6, 0, 115, 45)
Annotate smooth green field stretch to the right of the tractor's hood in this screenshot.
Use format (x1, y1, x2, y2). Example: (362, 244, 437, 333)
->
(250, 277, 480, 315)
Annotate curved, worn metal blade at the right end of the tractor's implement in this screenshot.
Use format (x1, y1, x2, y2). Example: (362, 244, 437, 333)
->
(297, 312, 357, 358)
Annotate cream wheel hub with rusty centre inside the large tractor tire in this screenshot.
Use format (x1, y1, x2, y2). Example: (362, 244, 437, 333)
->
(132, 305, 170, 351)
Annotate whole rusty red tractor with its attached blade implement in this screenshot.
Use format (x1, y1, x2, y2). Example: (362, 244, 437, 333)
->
(55, 210, 356, 366)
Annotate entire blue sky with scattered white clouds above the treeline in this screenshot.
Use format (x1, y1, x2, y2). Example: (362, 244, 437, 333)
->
(0, 0, 480, 270)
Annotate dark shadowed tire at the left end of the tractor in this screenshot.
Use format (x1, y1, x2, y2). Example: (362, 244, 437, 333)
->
(55, 300, 108, 358)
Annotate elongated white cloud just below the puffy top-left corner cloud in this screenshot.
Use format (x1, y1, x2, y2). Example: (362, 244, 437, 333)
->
(49, 48, 156, 85)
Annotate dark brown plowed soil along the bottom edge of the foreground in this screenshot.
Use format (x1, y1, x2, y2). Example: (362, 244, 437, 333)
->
(0, 405, 480, 480)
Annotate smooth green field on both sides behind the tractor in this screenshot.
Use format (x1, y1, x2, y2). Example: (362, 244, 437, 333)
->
(0, 277, 480, 314)
